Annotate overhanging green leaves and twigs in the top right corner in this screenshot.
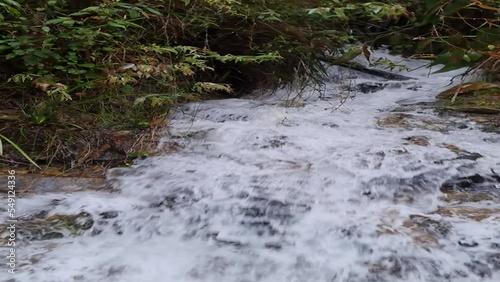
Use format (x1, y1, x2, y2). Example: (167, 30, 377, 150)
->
(364, 0, 500, 80)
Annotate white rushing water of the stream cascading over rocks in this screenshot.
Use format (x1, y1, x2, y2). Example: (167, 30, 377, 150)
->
(0, 53, 500, 282)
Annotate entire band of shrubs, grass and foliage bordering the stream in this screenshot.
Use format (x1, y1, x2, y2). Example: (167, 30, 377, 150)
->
(0, 0, 500, 173)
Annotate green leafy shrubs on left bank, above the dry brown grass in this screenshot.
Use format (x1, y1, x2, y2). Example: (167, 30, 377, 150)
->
(0, 0, 407, 129)
